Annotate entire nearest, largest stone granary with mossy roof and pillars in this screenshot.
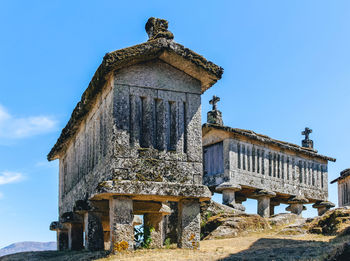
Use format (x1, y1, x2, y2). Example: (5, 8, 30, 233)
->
(48, 18, 223, 250)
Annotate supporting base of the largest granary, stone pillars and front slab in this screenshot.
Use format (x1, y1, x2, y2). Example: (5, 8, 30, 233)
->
(50, 180, 211, 251)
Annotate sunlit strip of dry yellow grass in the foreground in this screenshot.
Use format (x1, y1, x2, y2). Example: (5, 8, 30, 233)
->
(99, 233, 344, 261)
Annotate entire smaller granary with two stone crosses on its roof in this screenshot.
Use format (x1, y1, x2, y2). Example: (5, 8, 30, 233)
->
(202, 96, 335, 217)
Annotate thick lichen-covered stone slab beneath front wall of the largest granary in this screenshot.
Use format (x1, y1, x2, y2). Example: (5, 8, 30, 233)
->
(90, 180, 211, 202)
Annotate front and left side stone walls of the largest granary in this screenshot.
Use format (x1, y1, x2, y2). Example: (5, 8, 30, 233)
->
(59, 60, 202, 215)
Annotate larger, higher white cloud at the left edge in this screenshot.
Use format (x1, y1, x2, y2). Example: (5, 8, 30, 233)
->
(0, 105, 57, 139)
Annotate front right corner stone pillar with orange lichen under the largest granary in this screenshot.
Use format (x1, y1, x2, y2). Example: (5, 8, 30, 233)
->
(177, 199, 200, 249)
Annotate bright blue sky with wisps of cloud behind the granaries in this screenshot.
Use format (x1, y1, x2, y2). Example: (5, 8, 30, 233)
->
(0, 0, 350, 247)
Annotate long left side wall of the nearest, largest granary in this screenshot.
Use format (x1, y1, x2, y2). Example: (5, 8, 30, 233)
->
(59, 77, 113, 215)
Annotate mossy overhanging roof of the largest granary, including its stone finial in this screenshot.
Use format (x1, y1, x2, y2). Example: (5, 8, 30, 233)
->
(47, 18, 223, 160)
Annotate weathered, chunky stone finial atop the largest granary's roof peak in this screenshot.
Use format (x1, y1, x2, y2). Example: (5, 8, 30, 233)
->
(145, 17, 174, 41)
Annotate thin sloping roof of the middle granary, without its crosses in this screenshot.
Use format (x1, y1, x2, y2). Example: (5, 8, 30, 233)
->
(202, 123, 336, 162)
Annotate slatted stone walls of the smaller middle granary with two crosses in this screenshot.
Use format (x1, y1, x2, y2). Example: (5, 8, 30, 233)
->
(204, 129, 328, 201)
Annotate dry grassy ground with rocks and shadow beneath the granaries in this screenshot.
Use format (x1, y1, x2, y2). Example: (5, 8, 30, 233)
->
(0, 203, 350, 261)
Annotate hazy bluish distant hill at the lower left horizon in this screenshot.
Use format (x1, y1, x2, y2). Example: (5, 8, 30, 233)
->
(0, 241, 57, 256)
